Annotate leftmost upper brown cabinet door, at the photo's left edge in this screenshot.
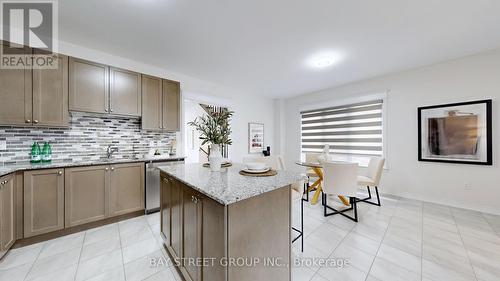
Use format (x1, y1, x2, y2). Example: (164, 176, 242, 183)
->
(0, 62, 33, 125)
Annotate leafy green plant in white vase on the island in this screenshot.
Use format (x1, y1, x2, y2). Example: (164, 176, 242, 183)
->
(188, 109, 233, 172)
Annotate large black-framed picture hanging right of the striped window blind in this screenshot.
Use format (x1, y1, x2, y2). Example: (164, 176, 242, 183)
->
(418, 100, 493, 165)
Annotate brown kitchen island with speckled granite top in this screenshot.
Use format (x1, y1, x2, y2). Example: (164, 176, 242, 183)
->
(159, 164, 303, 281)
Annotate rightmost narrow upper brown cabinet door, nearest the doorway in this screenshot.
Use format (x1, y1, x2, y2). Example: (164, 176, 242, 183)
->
(162, 79, 181, 131)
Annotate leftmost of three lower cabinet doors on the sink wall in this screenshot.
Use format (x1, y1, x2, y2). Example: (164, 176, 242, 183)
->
(24, 169, 64, 238)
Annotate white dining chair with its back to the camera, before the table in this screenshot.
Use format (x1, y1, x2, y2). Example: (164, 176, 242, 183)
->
(322, 162, 358, 222)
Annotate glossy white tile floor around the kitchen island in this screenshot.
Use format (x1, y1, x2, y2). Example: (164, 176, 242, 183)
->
(0, 192, 500, 281)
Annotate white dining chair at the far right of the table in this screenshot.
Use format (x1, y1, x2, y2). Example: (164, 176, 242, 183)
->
(358, 157, 385, 206)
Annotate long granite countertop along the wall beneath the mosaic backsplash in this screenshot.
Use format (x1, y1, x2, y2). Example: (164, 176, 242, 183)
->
(0, 155, 186, 177)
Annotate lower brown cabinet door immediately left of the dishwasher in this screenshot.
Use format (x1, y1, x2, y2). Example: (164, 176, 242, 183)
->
(109, 163, 144, 216)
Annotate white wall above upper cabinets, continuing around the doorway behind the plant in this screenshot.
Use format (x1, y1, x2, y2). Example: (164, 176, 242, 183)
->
(59, 39, 274, 162)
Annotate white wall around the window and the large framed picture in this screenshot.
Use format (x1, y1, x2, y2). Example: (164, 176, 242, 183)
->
(282, 49, 500, 214)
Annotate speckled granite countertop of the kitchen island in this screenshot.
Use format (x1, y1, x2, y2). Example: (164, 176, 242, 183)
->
(159, 163, 305, 205)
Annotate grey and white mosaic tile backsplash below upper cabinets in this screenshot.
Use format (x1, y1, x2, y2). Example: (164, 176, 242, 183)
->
(0, 112, 176, 165)
